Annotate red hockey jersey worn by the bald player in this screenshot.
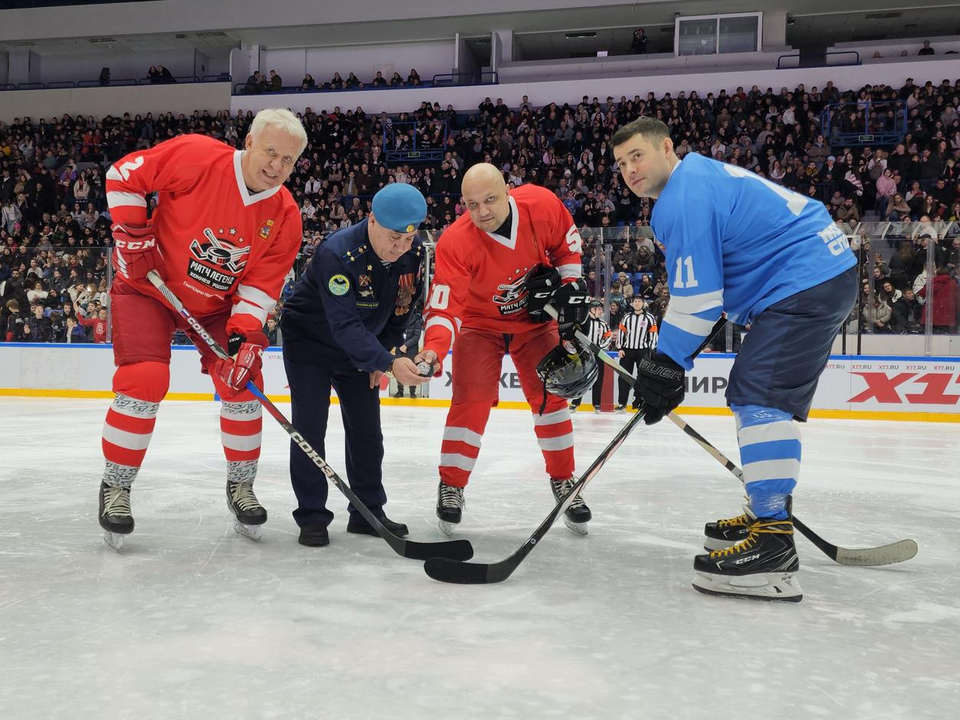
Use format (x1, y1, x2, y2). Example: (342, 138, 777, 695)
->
(424, 185, 582, 359)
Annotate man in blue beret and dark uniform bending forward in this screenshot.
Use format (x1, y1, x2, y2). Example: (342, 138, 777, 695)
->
(280, 183, 429, 547)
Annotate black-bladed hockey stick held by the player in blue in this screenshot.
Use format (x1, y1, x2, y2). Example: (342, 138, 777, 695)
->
(423, 318, 727, 585)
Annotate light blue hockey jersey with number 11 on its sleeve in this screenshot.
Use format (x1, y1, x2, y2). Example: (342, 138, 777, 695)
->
(650, 153, 856, 370)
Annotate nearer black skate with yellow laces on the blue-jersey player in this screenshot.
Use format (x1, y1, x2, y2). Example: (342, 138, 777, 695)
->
(693, 510, 803, 602)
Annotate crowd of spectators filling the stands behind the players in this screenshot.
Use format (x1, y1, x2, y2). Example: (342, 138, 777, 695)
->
(0, 71, 960, 342)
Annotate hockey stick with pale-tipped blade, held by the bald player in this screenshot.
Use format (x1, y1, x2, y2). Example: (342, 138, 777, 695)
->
(560, 306, 918, 567)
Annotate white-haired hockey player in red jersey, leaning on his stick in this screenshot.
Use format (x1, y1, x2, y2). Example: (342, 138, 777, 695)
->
(100, 110, 307, 549)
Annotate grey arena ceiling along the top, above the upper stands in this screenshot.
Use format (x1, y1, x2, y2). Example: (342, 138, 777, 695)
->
(0, 0, 960, 59)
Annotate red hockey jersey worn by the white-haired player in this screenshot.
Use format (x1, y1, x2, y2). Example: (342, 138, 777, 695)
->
(106, 135, 303, 334)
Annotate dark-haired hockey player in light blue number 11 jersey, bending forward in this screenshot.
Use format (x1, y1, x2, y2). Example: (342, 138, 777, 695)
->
(610, 118, 857, 602)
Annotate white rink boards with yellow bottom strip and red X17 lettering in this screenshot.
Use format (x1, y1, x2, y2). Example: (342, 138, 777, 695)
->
(0, 343, 960, 422)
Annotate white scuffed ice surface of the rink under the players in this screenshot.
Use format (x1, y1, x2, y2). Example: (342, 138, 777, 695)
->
(0, 399, 960, 720)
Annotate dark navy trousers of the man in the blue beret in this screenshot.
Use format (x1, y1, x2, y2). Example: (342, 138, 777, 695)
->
(283, 357, 387, 527)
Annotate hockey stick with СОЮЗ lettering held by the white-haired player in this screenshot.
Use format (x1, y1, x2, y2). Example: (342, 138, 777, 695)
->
(147, 270, 473, 560)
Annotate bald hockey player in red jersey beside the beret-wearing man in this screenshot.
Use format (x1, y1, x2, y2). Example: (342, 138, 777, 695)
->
(417, 163, 590, 534)
